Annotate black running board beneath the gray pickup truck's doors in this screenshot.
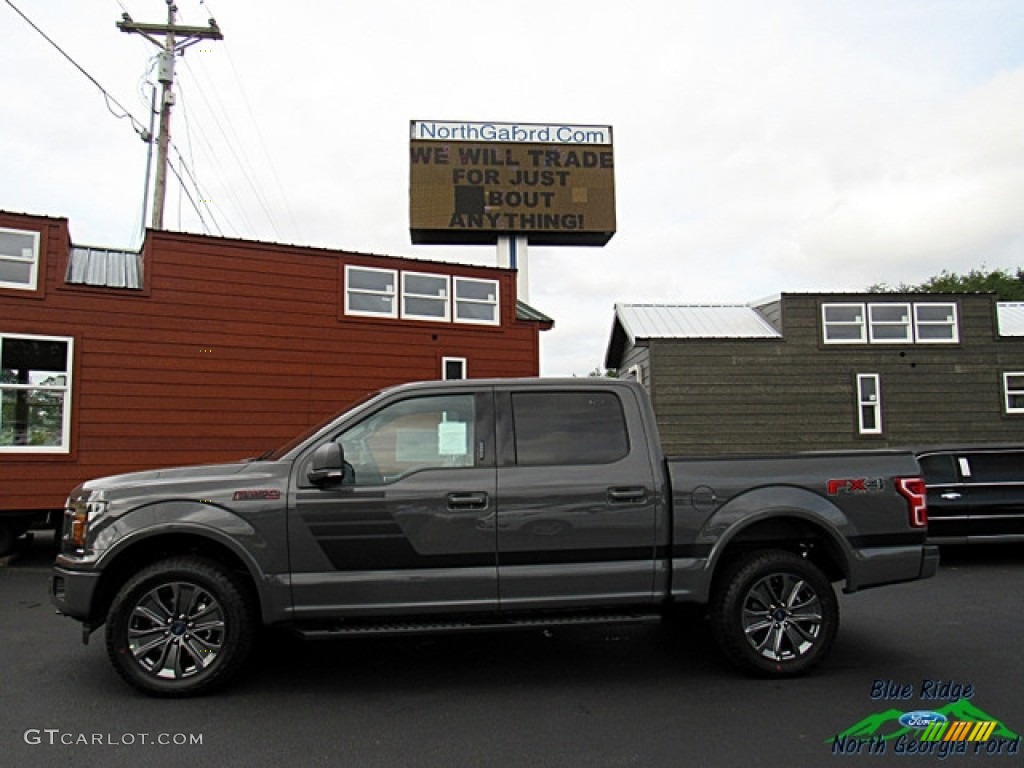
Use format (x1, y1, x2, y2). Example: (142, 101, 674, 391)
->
(293, 613, 662, 640)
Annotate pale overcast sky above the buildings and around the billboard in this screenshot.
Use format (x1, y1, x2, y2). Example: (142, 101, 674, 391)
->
(0, 0, 1024, 376)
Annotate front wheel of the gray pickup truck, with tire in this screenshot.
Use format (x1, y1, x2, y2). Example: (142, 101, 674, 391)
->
(106, 556, 256, 696)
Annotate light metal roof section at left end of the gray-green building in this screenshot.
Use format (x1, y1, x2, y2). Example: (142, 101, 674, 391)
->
(615, 304, 782, 343)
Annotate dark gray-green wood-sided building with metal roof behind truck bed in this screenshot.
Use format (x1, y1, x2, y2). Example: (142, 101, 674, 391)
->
(605, 293, 1024, 455)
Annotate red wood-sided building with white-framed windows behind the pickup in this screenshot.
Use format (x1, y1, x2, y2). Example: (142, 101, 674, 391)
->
(0, 207, 552, 536)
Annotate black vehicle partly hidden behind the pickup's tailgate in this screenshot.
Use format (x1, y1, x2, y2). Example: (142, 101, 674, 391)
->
(918, 445, 1024, 544)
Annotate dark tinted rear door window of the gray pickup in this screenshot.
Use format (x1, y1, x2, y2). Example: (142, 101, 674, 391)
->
(512, 392, 630, 466)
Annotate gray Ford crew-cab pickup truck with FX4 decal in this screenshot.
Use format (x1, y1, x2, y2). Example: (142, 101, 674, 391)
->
(50, 379, 938, 696)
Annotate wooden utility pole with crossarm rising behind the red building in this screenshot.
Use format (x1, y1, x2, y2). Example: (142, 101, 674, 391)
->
(118, 0, 224, 229)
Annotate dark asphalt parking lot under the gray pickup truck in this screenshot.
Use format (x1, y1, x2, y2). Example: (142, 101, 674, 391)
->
(0, 538, 1024, 768)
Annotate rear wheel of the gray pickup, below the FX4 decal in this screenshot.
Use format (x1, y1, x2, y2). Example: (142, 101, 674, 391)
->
(711, 550, 839, 677)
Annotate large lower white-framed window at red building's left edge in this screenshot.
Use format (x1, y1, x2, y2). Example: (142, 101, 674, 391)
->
(0, 334, 74, 454)
